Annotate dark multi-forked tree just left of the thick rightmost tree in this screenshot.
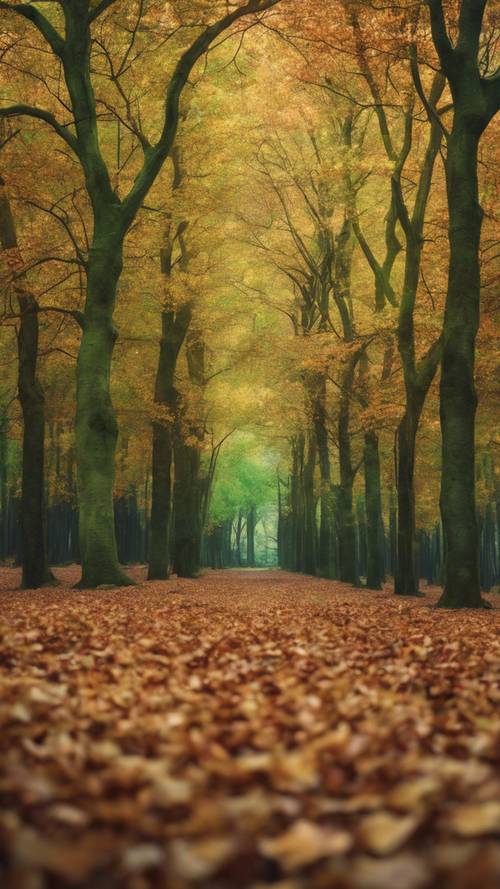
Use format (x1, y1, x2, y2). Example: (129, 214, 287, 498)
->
(348, 8, 446, 596)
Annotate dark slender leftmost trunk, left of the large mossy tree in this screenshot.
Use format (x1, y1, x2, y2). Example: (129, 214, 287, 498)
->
(0, 170, 54, 589)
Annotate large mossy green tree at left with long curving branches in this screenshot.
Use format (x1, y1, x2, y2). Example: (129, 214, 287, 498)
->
(0, 0, 279, 587)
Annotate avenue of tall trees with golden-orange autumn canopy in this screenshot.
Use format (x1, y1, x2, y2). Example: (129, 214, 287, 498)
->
(0, 0, 500, 608)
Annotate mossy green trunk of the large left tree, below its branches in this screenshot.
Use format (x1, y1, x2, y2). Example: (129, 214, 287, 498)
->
(76, 232, 133, 588)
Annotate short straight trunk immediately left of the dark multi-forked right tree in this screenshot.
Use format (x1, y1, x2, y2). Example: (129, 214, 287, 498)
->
(363, 430, 385, 590)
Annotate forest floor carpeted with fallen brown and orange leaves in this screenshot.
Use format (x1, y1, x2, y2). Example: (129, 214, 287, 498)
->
(0, 568, 500, 889)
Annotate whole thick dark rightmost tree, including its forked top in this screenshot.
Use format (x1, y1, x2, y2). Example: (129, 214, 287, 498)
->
(427, 0, 500, 608)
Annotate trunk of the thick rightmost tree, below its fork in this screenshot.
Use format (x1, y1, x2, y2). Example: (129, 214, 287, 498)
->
(438, 128, 483, 608)
